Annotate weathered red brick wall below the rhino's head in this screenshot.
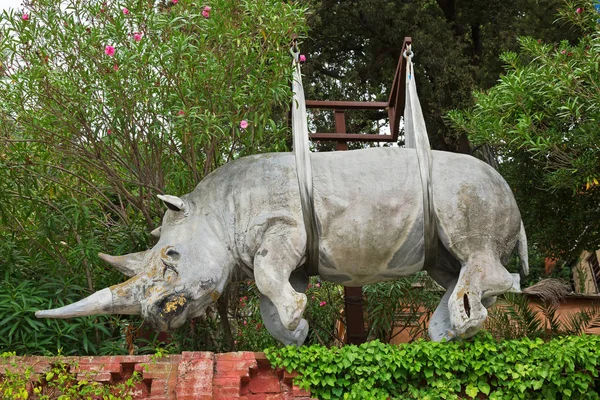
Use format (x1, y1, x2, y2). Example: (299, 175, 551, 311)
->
(0, 352, 310, 400)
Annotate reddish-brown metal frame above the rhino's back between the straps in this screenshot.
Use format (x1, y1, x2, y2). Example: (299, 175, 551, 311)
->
(306, 37, 412, 150)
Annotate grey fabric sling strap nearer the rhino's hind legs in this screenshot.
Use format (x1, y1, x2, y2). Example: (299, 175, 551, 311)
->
(404, 46, 438, 267)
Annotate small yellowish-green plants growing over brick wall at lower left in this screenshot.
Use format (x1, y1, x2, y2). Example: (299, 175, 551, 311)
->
(0, 355, 141, 400)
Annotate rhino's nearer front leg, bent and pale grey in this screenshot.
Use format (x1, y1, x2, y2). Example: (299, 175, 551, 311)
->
(254, 224, 307, 331)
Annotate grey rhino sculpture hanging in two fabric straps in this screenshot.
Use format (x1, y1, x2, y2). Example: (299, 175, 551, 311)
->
(36, 148, 528, 345)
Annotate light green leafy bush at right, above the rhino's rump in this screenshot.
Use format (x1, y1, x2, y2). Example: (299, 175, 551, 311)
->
(448, 0, 600, 256)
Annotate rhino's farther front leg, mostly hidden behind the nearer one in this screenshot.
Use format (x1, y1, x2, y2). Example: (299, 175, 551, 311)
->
(260, 269, 308, 346)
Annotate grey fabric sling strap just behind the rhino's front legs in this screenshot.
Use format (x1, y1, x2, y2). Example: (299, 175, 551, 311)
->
(292, 49, 319, 275)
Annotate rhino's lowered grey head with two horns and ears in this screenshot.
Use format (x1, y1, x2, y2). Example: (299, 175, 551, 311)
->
(35, 195, 233, 331)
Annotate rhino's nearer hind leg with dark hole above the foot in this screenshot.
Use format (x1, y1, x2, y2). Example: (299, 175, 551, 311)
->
(448, 255, 513, 338)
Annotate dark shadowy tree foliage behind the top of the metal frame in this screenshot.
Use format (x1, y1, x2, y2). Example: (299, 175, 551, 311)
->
(304, 0, 577, 153)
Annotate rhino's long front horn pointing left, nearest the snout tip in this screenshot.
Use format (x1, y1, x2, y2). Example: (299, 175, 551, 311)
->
(35, 284, 141, 318)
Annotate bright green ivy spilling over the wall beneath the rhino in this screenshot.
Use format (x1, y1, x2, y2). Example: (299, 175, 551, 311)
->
(265, 335, 600, 400)
